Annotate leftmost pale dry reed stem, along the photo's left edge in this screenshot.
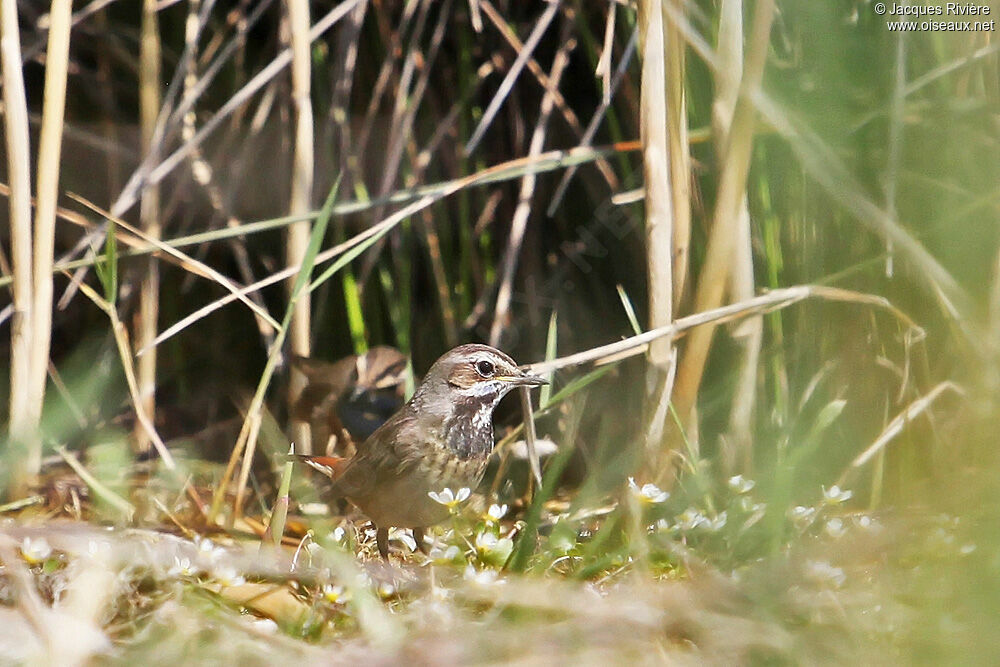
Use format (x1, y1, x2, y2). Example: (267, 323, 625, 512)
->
(0, 0, 41, 497)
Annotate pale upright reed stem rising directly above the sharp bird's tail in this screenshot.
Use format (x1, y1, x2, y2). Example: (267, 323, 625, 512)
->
(285, 0, 315, 454)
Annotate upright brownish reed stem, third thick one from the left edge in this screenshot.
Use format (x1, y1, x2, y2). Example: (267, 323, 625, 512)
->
(132, 0, 161, 452)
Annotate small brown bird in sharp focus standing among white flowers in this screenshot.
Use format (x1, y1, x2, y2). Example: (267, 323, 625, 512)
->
(300, 345, 545, 558)
